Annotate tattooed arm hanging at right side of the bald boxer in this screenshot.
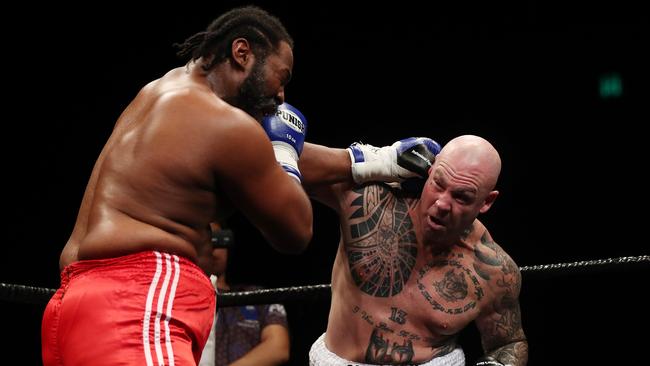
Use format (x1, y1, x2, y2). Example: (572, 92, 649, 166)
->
(476, 249, 528, 366)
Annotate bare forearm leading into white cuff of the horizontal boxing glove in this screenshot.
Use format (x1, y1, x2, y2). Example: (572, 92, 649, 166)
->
(298, 142, 354, 207)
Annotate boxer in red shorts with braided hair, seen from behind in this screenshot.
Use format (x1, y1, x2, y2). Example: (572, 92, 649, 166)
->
(42, 7, 312, 366)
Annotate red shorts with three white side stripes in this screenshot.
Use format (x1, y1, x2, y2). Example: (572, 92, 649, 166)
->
(41, 251, 216, 366)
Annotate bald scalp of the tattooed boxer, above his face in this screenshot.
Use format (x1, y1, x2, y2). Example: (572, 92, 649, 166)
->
(436, 135, 501, 191)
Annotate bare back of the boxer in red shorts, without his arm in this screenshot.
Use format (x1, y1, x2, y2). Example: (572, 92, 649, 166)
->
(61, 68, 232, 267)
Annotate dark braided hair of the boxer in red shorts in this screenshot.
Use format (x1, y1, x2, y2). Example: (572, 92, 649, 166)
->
(174, 6, 293, 71)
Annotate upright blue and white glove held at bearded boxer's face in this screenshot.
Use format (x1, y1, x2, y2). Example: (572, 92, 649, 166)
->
(262, 103, 307, 182)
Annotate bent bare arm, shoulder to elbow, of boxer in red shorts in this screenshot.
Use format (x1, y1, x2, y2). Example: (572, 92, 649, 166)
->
(215, 113, 313, 253)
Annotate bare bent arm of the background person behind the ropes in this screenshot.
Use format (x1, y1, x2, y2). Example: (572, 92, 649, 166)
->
(230, 324, 289, 366)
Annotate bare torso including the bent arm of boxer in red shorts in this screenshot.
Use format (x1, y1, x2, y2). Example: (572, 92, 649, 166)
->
(60, 58, 311, 268)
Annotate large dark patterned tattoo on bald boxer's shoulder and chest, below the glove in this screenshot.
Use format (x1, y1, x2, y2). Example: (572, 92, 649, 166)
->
(345, 185, 417, 297)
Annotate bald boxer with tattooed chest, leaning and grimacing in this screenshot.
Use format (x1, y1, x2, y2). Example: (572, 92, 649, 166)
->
(300, 136, 528, 366)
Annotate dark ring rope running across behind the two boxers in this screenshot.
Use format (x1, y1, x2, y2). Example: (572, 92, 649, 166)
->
(0, 255, 650, 307)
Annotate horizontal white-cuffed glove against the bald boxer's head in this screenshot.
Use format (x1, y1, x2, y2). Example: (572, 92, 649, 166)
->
(348, 137, 440, 186)
